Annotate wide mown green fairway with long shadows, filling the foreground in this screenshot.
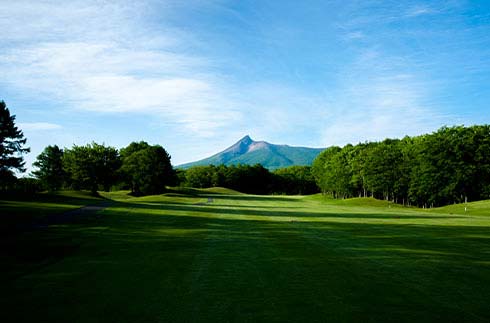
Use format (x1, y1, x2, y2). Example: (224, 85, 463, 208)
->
(0, 189, 490, 322)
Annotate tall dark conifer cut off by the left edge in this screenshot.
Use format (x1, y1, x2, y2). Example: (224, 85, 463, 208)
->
(0, 101, 30, 183)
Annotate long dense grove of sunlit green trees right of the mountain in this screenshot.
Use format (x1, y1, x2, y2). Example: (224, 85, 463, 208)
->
(312, 125, 490, 207)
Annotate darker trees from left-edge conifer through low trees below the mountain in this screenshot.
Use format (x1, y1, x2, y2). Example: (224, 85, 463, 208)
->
(0, 101, 318, 195)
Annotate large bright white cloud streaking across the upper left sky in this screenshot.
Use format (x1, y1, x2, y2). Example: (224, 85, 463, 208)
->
(0, 1, 240, 136)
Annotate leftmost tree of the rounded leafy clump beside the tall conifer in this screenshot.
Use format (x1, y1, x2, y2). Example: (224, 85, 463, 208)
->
(32, 145, 65, 191)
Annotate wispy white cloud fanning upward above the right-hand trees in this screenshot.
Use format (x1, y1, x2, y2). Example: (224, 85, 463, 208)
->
(323, 49, 455, 145)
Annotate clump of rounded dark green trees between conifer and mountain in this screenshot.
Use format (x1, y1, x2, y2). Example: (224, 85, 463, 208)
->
(33, 141, 176, 195)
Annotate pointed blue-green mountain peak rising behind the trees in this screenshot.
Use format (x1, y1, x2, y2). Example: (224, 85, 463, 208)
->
(177, 135, 324, 170)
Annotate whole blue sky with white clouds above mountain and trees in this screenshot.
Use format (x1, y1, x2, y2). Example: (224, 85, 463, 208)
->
(0, 0, 490, 171)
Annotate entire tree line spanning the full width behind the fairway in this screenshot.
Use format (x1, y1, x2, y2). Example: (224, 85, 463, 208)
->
(0, 101, 490, 207)
